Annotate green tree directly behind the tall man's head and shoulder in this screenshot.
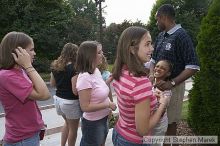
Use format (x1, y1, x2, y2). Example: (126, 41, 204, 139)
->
(148, 0, 211, 46)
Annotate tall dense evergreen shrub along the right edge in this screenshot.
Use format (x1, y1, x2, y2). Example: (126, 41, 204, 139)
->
(188, 0, 220, 139)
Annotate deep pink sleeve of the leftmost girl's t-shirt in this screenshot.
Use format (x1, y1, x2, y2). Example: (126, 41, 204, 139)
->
(5, 75, 33, 103)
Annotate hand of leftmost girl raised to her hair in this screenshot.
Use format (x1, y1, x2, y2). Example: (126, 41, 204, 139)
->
(12, 47, 32, 68)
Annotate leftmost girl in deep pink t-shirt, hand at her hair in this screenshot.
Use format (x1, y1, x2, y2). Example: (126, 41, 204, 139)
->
(0, 32, 50, 146)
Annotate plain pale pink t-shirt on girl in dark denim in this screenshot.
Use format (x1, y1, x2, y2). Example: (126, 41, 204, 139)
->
(76, 68, 110, 121)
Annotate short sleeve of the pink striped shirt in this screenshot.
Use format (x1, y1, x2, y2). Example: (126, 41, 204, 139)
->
(132, 78, 153, 104)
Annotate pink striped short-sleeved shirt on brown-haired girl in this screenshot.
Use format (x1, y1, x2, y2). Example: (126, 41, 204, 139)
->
(113, 70, 157, 144)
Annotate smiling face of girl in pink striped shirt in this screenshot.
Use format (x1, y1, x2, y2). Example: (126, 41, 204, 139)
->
(137, 32, 154, 63)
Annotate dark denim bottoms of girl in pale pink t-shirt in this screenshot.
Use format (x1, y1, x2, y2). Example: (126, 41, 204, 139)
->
(80, 116, 108, 146)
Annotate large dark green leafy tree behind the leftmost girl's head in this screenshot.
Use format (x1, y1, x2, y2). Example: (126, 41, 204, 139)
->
(0, 0, 73, 59)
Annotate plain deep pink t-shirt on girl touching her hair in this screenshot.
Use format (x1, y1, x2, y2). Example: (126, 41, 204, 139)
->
(0, 69, 44, 142)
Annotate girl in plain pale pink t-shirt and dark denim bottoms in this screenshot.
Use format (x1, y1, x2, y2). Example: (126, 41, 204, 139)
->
(76, 41, 116, 146)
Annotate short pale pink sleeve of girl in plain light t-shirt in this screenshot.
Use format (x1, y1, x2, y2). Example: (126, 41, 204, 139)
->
(76, 73, 92, 92)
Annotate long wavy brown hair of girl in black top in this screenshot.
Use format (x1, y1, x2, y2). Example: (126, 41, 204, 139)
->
(51, 43, 78, 71)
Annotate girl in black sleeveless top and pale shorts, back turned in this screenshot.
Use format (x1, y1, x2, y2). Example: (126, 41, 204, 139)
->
(50, 43, 82, 146)
